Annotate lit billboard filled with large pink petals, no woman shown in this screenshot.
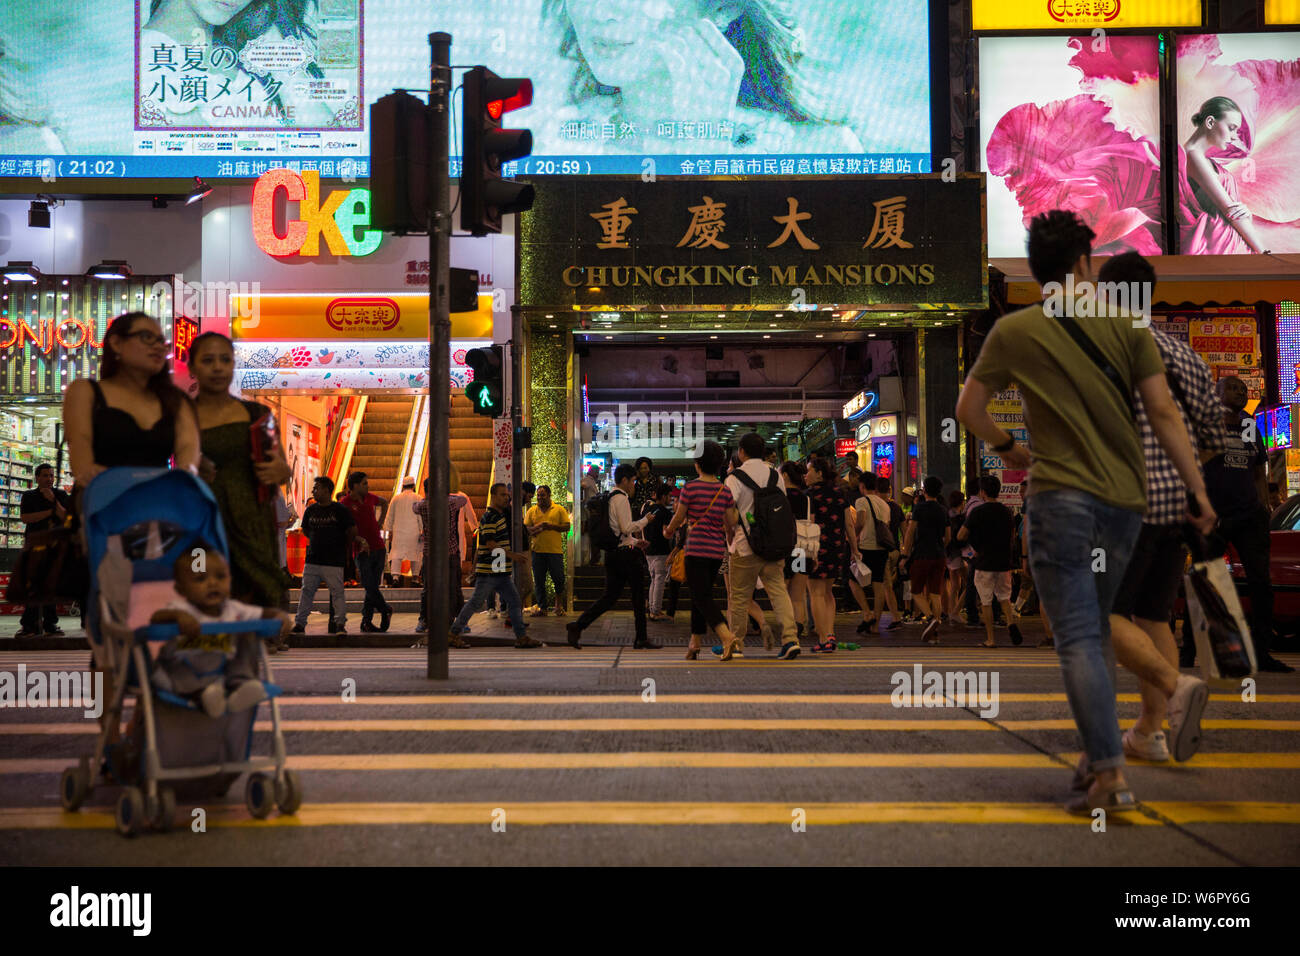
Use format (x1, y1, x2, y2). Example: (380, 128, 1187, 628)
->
(979, 34, 1164, 258)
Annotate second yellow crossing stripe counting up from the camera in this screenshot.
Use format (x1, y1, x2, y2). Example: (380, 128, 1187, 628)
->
(0, 750, 1300, 775)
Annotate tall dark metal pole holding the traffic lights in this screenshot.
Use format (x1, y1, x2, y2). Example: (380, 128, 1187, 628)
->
(424, 33, 451, 680)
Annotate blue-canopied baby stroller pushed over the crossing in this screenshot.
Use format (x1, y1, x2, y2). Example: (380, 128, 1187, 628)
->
(60, 468, 303, 836)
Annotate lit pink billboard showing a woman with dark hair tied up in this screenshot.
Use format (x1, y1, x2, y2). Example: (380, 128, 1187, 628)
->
(1174, 34, 1300, 255)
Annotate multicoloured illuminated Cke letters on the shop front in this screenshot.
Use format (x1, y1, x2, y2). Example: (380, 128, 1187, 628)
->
(252, 169, 384, 256)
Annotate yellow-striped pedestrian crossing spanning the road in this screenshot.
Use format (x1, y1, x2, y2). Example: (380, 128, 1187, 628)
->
(0, 648, 1300, 862)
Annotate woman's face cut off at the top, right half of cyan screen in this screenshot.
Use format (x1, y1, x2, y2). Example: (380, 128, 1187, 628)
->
(566, 0, 701, 86)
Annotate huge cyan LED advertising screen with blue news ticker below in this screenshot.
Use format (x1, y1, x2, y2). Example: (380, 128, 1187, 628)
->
(0, 0, 930, 179)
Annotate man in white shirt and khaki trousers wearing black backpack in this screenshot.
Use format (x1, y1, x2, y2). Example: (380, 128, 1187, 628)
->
(725, 432, 801, 661)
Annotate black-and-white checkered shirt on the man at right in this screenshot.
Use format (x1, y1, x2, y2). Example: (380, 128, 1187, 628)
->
(1135, 329, 1226, 525)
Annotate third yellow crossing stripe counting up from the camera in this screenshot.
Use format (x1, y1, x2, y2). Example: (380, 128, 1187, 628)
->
(0, 715, 1300, 736)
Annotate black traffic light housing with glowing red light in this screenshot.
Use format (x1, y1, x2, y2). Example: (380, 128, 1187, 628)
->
(460, 66, 533, 235)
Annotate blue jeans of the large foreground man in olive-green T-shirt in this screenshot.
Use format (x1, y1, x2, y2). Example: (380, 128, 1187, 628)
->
(1027, 489, 1141, 773)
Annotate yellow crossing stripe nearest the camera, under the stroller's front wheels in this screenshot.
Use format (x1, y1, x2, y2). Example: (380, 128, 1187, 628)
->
(0, 800, 1300, 836)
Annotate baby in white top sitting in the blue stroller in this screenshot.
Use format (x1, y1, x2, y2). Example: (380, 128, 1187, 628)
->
(150, 546, 290, 717)
